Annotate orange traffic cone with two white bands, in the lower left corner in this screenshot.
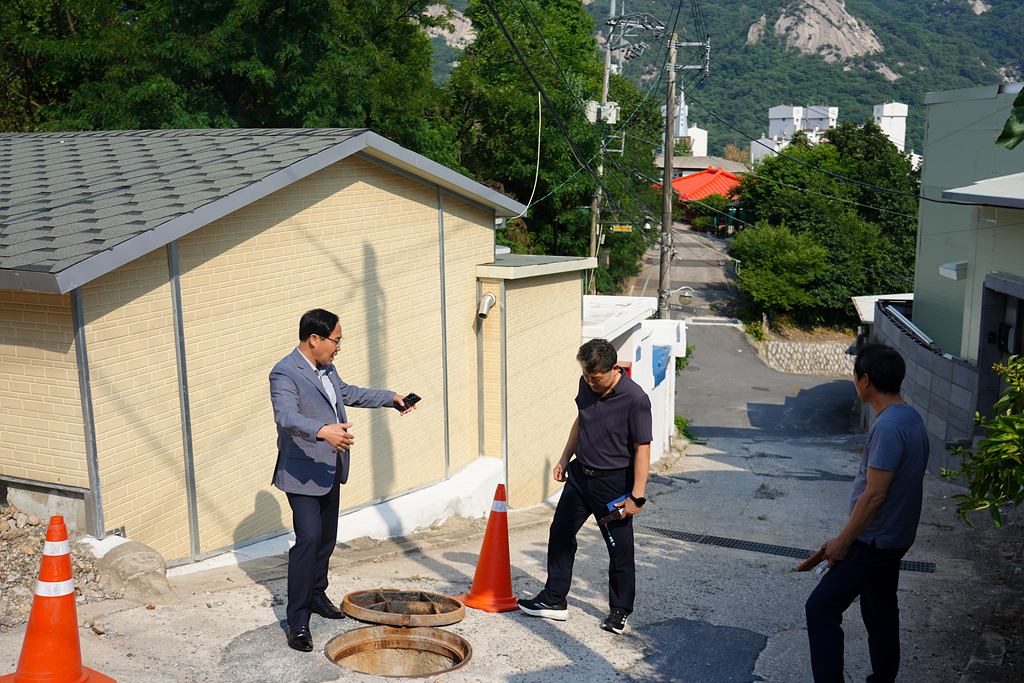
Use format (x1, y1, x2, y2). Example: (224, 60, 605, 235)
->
(0, 517, 116, 683)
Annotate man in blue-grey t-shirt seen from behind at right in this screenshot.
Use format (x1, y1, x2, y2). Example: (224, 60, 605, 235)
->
(806, 344, 928, 683)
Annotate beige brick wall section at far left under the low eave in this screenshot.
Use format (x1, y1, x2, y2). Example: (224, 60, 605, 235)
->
(0, 290, 89, 488)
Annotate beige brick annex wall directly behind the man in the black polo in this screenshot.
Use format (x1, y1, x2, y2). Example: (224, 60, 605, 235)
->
(505, 272, 583, 508)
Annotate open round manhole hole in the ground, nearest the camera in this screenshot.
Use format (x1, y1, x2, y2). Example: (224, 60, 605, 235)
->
(324, 626, 473, 678)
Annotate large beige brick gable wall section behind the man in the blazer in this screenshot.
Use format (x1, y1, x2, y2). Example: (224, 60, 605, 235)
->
(180, 159, 479, 552)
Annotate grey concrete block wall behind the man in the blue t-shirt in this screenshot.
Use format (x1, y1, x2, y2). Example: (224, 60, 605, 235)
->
(868, 311, 979, 475)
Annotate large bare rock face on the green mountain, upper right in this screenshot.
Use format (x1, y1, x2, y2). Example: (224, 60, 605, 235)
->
(746, 0, 883, 61)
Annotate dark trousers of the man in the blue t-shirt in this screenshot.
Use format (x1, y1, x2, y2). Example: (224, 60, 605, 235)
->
(806, 541, 909, 683)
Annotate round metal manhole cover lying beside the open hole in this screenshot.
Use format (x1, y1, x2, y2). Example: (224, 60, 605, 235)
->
(341, 589, 466, 627)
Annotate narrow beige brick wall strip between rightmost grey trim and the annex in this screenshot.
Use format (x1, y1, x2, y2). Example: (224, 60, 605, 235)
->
(442, 196, 501, 472)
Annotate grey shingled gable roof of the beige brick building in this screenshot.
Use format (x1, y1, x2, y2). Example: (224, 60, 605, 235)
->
(0, 129, 519, 292)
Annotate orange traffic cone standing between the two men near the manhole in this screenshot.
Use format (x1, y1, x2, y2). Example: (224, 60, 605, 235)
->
(454, 483, 519, 610)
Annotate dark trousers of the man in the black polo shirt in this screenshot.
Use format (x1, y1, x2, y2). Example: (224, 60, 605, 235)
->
(538, 460, 636, 614)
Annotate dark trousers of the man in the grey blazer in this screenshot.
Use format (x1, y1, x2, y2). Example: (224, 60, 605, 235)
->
(286, 467, 341, 629)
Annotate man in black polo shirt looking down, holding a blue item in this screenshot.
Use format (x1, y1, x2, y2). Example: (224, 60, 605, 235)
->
(518, 339, 651, 633)
